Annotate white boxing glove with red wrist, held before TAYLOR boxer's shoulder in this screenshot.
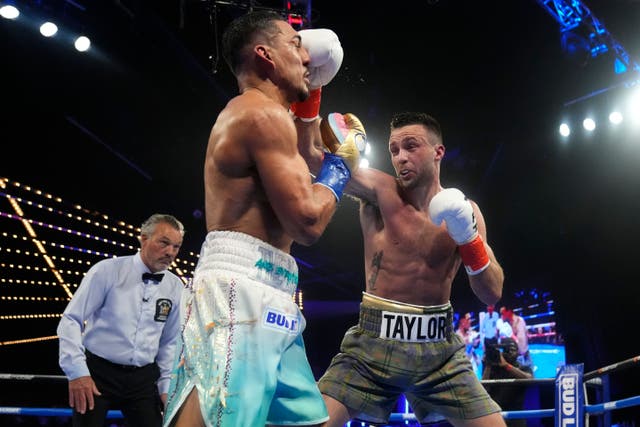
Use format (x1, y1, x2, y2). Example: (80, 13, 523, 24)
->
(429, 188, 490, 275)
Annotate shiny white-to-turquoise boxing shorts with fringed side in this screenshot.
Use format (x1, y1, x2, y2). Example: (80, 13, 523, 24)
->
(165, 231, 328, 426)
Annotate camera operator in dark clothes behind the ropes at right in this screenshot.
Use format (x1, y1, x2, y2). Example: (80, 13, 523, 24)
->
(482, 338, 533, 427)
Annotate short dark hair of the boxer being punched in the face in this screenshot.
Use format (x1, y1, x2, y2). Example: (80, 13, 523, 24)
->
(222, 10, 285, 75)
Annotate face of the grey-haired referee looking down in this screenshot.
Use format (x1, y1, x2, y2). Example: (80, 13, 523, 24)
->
(140, 222, 182, 273)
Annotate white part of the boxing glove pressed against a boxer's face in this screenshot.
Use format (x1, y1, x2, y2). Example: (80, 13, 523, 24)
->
(298, 28, 344, 89)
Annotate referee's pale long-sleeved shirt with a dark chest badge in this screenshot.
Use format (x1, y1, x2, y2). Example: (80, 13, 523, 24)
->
(58, 252, 183, 393)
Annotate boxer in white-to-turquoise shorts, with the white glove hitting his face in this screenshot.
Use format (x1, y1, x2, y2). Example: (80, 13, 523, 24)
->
(164, 10, 364, 427)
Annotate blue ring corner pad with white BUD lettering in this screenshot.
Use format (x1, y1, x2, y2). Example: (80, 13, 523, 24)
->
(555, 363, 584, 427)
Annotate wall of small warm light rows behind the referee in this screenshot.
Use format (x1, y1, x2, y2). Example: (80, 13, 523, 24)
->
(0, 177, 198, 345)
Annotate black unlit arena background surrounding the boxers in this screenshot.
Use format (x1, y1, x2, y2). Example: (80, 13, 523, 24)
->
(0, 0, 640, 424)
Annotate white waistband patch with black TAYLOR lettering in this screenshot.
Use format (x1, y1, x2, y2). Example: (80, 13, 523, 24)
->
(380, 311, 447, 342)
